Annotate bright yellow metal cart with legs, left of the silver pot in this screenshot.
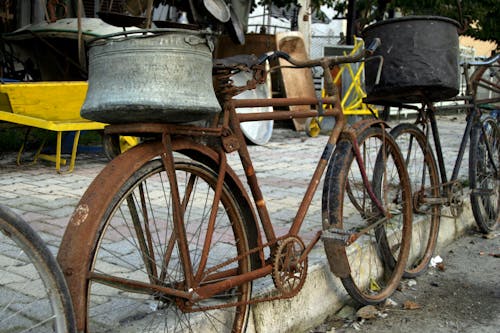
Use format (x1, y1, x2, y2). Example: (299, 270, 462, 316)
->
(0, 82, 106, 172)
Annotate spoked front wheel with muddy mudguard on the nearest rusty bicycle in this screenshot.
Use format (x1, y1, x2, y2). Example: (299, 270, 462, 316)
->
(323, 128, 411, 304)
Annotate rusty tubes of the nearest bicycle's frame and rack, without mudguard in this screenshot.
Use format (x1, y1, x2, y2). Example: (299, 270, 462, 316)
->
(99, 92, 388, 304)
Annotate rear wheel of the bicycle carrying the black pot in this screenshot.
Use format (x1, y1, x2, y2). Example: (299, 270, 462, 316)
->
(388, 124, 441, 278)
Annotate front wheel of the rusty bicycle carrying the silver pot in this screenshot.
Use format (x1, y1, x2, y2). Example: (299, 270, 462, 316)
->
(323, 127, 412, 305)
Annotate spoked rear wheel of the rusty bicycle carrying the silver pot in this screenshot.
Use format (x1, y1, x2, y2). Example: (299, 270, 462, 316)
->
(86, 159, 252, 332)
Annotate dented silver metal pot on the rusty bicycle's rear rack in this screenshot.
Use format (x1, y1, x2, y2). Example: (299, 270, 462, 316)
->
(81, 29, 221, 124)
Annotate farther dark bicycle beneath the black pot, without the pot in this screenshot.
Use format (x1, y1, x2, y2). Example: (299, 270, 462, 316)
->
(364, 54, 500, 277)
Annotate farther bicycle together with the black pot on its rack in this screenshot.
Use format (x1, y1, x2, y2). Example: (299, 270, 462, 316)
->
(363, 16, 500, 277)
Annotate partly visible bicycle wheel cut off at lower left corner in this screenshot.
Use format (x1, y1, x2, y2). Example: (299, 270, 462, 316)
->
(0, 205, 75, 333)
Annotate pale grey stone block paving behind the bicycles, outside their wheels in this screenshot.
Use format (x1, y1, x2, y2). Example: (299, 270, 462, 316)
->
(0, 115, 468, 330)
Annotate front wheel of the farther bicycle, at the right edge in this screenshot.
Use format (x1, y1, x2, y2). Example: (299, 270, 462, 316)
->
(469, 116, 500, 233)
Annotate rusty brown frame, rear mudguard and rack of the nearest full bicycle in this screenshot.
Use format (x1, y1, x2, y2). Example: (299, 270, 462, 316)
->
(58, 40, 408, 328)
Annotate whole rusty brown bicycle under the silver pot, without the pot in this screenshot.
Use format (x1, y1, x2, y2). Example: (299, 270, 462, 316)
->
(58, 31, 412, 332)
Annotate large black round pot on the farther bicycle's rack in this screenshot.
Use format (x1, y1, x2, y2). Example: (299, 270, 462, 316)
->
(363, 16, 459, 103)
